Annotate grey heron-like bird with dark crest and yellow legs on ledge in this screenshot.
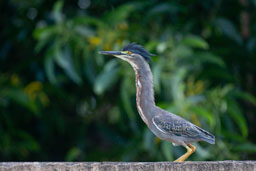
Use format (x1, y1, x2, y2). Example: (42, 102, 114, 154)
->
(99, 43, 215, 162)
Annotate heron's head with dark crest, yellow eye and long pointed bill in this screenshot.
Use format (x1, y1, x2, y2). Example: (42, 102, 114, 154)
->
(99, 43, 154, 64)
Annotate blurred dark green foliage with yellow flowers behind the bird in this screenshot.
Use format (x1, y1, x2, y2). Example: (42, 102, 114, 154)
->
(0, 0, 256, 161)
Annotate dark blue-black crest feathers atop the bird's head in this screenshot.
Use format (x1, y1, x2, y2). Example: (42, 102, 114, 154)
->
(123, 43, 155, 61)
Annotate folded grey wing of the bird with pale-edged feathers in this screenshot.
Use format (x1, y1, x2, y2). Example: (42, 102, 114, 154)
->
(152, 115, 201, 138)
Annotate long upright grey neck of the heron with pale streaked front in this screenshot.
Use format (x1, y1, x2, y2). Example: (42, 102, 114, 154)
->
(132, 61, 155, 127)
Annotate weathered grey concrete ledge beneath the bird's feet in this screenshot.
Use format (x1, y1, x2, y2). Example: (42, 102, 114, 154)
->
(0, 161, 256, 171)
